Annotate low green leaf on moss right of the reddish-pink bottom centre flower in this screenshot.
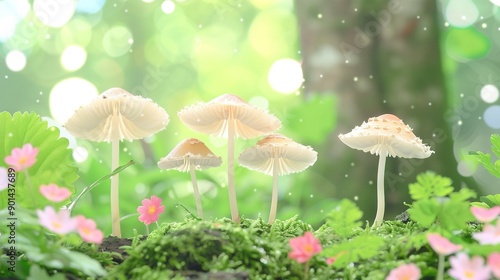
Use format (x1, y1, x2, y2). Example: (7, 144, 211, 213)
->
(322, 235, 384, 268)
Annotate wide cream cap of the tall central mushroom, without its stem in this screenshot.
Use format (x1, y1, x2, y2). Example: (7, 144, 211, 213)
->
(178, 94, 281, 139)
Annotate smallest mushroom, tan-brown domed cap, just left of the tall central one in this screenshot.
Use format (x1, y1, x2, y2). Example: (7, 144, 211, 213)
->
(158, 138, 222, 218)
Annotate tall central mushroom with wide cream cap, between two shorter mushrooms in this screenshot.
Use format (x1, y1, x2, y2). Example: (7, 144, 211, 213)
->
(178, 94, 281, 222)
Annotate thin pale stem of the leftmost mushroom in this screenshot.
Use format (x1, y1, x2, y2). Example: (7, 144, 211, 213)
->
(111, 139, 122, 238)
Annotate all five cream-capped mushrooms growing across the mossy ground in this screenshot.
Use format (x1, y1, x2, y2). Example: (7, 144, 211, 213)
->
(64, 88, 433, 237)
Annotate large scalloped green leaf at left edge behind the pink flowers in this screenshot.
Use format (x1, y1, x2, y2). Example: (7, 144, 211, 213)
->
(0, 112, 78, 209)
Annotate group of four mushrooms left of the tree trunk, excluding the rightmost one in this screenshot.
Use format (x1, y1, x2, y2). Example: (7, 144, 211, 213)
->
(64, 88, 317, 237)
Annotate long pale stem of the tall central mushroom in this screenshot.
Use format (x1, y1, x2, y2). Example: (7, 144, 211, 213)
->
(227, 116, 240, 223)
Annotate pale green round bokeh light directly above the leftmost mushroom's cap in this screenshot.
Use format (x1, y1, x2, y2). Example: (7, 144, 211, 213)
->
(102, 25, 133, 57)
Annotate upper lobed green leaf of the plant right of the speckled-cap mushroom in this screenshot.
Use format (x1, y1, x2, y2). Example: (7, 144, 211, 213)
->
(409, 171, 453, 200)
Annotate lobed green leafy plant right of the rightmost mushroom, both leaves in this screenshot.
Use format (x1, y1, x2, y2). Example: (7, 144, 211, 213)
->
(408, 172, 476, 231)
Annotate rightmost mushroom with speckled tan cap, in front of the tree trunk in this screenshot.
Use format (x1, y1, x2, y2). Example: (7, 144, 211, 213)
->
(339, 114, 434, 227)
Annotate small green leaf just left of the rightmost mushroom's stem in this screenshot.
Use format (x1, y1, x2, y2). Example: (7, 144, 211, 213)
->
(326, 199, 363, 238)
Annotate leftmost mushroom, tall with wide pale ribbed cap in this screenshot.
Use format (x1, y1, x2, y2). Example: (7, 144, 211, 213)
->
(64, 88, 169, 237)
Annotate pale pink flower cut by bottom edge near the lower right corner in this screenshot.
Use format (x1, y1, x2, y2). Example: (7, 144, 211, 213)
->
(448, 253, 490, 280)
